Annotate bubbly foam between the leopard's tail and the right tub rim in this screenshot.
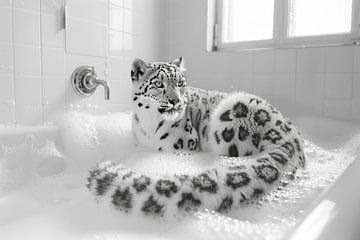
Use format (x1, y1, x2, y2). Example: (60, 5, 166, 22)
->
(195, 140, 354, 239)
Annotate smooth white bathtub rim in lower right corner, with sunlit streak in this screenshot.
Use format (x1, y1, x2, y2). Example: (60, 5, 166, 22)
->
(284, 156, 360, 240)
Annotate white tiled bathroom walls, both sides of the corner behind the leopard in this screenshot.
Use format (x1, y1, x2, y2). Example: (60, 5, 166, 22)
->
(0, 0, 360, 125)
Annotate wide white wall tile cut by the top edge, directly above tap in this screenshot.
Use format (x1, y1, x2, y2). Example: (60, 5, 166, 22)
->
(67, 0, 108, 24)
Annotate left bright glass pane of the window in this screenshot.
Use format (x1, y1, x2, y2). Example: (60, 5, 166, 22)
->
(222, 0, 274, 42)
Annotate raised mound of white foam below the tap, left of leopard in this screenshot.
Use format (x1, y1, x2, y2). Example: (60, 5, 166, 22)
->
(59, 112, 135, 171)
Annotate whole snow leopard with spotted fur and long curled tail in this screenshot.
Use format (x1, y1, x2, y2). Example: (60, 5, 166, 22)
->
(88, 58, 305, 216)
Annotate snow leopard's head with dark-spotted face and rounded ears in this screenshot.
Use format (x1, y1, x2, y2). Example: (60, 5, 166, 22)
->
(131, 57, 187, 121)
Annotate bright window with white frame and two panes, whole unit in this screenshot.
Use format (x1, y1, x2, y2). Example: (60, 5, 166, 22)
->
(209, 0, 360, 49)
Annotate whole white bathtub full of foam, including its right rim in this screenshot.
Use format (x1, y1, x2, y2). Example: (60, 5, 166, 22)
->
(0, 113, 360, 240)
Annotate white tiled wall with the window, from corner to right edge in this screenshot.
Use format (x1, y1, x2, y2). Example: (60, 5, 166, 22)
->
(166, 0, 360, 119)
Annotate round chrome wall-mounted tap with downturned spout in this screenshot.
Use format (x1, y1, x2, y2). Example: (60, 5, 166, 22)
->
(71, 66, 110, 100)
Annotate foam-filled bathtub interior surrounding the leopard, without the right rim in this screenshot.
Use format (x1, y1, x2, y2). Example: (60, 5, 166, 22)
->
(0, 112, 360, 239)
